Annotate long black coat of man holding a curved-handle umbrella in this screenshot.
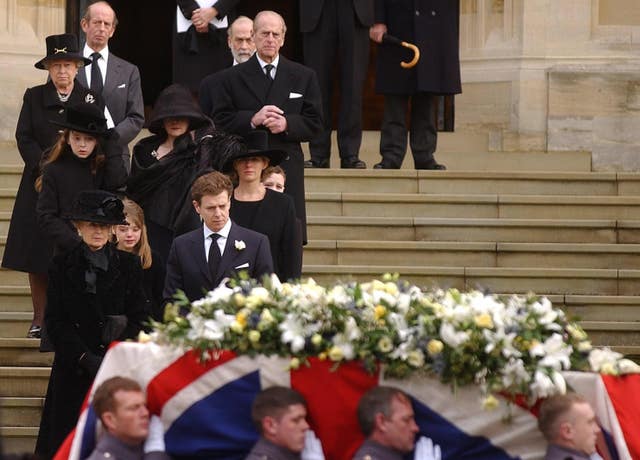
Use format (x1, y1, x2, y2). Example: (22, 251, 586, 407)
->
(375, 0, 462, 95)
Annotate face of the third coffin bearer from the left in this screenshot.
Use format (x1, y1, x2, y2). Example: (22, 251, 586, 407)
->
(377, 395, 419, 453)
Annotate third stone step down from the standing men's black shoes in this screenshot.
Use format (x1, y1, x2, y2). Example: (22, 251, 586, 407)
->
(307, 216, 640, 244)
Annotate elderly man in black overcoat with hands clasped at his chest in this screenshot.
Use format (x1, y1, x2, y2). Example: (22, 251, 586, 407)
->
(213, 11, 322, 242)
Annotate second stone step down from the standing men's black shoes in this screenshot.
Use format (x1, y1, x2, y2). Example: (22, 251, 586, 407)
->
(307, 193, 640, 219)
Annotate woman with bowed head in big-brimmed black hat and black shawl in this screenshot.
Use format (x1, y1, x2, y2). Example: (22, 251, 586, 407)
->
(127, 84, 210, 263)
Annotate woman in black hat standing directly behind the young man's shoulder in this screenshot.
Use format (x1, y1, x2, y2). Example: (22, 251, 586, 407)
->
(222, 131, 302, 280)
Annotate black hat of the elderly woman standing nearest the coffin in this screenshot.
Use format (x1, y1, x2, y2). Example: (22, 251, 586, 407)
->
(66, 190, 128, 225)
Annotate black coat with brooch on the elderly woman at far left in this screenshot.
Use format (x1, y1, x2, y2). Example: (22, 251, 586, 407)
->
(2, 82, 102, 273)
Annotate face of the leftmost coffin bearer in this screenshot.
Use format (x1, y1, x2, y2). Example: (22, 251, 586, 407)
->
(102, 390, 149, 445)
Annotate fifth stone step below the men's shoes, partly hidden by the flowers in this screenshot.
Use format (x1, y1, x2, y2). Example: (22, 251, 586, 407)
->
(303, 264, 640, 295)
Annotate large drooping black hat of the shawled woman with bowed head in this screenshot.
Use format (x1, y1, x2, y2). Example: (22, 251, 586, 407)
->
(148, 83, 209, 134)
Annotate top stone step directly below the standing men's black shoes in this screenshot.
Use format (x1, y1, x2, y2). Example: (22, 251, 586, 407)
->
(305, 169, 640, 196)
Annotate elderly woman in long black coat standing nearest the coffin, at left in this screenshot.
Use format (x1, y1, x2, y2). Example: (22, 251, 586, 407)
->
(36, 190, 150, 458)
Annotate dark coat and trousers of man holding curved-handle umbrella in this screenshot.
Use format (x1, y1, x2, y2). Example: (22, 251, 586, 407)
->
(375, 0, 461, 169)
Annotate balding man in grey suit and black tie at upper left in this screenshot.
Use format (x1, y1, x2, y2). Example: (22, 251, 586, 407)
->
(77, 1, 144, 172)
